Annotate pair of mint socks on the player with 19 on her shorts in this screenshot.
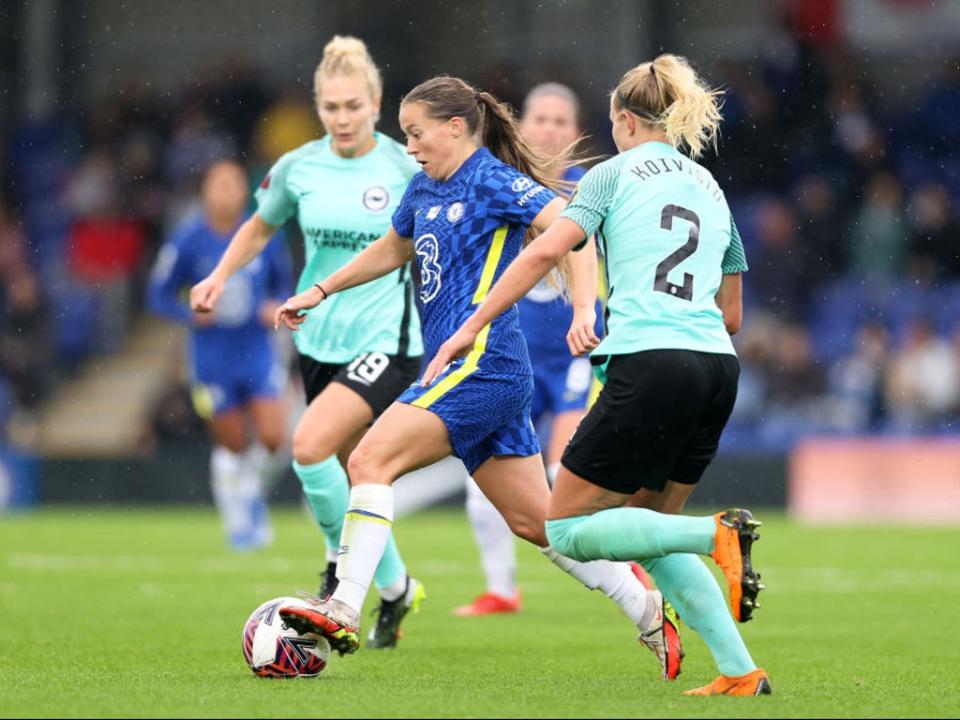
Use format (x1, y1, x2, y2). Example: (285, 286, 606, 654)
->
(293, 455, 407, 588)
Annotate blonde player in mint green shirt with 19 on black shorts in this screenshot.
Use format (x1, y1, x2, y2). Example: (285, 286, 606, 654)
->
(191, 36, 424, 648)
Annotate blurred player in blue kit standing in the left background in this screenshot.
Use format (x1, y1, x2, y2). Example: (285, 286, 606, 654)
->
(147, 160, 293, 550)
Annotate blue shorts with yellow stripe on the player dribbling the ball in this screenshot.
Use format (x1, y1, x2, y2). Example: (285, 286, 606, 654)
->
(397, 360, 540, 474)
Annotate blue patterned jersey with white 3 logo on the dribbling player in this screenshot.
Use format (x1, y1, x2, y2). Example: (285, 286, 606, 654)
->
(393, 148, 557, 375)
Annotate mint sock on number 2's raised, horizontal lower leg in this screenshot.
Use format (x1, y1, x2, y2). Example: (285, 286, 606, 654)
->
(547, 508, 716, 561)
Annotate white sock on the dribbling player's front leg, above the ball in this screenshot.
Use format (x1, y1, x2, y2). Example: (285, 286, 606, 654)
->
(333, 483, 393, 613)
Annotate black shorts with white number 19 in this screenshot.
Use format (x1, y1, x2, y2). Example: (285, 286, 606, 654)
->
(300, 352, 420, 417)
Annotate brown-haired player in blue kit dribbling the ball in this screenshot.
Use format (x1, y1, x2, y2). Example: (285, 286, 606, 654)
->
(276, 77, 681, 679)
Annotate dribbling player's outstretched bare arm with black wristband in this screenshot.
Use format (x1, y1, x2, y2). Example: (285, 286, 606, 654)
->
(274, 227, 413, 330)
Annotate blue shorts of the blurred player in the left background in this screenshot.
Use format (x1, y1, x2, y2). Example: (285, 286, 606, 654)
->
(193, 352, 287, 417)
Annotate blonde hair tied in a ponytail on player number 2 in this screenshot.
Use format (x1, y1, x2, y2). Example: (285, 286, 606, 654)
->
(613, 54, 723, 159)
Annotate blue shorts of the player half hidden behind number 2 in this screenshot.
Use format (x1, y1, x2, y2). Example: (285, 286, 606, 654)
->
(530, 348, 593, 422)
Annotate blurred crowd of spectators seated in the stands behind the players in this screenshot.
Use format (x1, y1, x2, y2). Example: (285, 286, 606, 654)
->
(0, 29, 960, 451)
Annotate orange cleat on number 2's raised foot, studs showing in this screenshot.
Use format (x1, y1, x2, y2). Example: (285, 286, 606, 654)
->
(710, 508, 764, 622)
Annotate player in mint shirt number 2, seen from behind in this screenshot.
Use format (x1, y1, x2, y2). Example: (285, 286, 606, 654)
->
(423, 55, 770, 695)
